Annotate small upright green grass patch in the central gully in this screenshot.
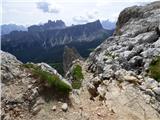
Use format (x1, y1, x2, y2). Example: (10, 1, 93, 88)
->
(71, 65, 84, 89)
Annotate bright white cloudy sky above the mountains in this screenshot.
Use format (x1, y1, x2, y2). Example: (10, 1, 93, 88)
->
(0, 0, 155, 25)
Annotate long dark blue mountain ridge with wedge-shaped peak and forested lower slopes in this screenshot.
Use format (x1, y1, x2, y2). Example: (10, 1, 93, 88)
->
(1, 20, 113, 62)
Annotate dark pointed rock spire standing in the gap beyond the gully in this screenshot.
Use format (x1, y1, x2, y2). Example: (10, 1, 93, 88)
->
(63, 46, 82, 73)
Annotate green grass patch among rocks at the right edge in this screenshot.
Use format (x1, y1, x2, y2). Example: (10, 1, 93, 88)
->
(149, 56, 160, 82)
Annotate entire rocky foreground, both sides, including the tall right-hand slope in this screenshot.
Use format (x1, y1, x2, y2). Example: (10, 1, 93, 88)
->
(1, 2, 160, 120)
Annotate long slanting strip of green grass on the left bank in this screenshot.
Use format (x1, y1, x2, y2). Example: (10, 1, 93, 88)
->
(23, 63, 72, 93)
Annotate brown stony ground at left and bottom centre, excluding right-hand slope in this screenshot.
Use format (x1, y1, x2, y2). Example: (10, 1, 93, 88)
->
(1, 52, 114, 120)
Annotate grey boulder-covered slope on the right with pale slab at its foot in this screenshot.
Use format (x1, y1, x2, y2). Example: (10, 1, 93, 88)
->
(88, 2, 160, 120)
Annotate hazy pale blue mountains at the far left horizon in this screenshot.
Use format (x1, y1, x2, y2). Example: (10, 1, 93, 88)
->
(0, 24, 27, 35)
